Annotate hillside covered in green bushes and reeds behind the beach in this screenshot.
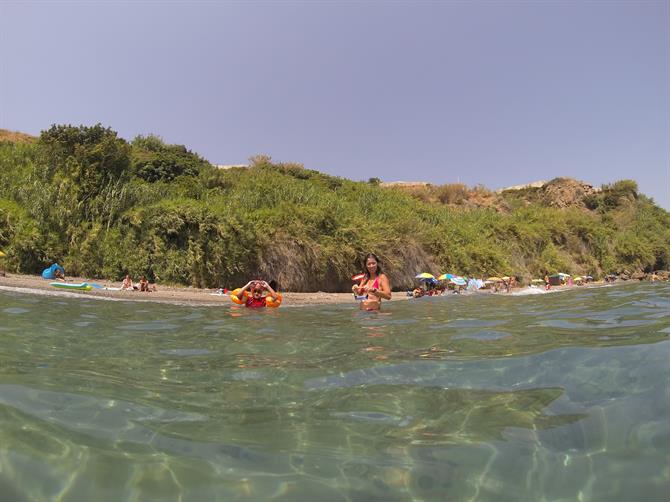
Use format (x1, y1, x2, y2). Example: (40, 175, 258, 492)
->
(0, 124, 670, 291)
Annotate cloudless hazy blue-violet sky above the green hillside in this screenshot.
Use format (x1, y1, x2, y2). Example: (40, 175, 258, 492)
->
(0, 0, 670, 209)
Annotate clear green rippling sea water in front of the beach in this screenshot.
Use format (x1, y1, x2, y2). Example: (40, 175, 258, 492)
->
(0, 284, 670, 502)
